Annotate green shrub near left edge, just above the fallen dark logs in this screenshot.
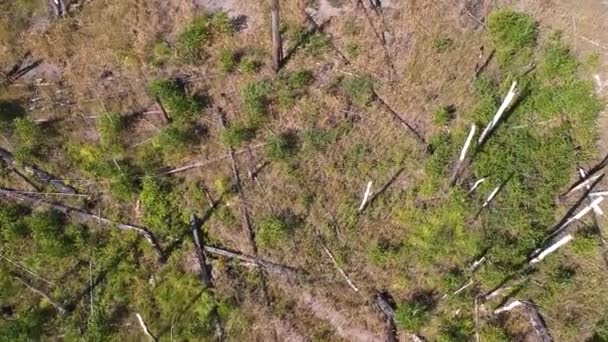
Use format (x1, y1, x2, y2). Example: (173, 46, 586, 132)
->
(14, 118, 49, 163)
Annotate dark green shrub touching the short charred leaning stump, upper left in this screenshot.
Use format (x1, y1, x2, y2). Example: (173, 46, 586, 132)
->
(150, 80, 202, 123)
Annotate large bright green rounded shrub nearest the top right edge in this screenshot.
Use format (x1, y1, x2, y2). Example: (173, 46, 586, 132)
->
(487, 9, 538, 65)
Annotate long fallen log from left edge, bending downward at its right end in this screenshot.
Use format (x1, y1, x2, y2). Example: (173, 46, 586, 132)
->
(0, 188, 165, 263)
